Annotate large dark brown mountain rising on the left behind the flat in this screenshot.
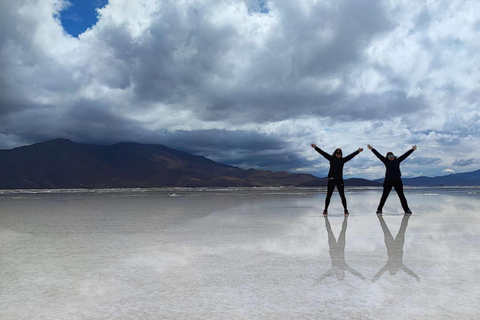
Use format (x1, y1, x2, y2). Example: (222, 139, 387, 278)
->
(0, 139, 379, 189)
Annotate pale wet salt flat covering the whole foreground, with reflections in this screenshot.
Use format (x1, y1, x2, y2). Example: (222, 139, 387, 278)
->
(0, 188, 480, 319)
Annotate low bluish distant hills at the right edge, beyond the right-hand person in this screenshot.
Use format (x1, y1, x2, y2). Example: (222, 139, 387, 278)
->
(375, 170, 480, 187)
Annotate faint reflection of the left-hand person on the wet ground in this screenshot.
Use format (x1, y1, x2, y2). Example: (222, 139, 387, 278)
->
(319, 216, 365, 281)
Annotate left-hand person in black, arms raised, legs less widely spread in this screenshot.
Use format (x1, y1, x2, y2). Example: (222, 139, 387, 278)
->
(311, 143, 363, 214)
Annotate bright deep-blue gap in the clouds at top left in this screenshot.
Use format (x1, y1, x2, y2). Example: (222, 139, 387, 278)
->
(60, 0, 108, 37)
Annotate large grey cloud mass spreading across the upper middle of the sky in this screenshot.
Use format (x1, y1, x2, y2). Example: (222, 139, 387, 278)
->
(71, 1, 398, 123)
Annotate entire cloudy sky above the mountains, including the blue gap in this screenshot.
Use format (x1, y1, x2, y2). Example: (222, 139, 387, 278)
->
(0, 0, 480, 179)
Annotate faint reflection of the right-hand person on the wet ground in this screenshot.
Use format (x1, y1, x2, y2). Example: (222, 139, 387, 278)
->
(372, 214, 420, 282)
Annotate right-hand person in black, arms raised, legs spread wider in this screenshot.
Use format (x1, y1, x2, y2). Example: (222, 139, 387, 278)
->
(368, 145, 417, 214)
